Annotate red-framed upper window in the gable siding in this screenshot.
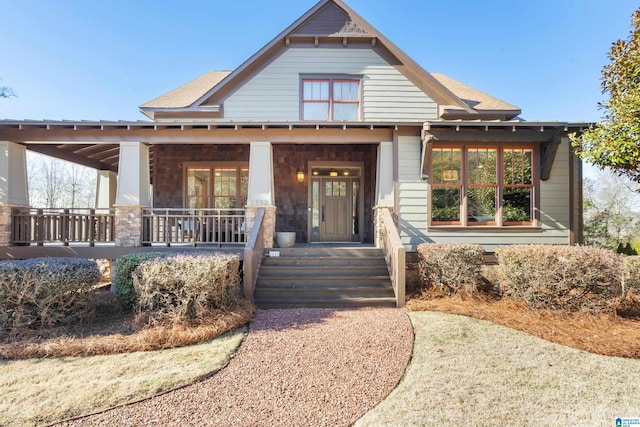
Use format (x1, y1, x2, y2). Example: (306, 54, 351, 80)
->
(302, 78, 360, 121)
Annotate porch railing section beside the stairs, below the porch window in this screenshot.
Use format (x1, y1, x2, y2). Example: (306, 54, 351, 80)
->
(142, 208, 247, 246)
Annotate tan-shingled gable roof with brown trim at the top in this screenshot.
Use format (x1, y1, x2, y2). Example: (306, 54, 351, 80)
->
(140, 0, 520, 119)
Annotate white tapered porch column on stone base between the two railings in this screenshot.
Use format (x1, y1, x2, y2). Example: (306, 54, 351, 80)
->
(115, 142, 151, 247)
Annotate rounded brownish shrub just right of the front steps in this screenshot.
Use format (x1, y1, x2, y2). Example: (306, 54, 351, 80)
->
(418, 243, 483, 295)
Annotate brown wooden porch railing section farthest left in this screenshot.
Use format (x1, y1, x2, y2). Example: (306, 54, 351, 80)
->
(11, 208, 115, 246)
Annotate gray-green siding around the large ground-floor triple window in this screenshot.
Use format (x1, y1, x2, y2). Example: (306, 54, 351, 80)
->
(397, 138, 571, 251)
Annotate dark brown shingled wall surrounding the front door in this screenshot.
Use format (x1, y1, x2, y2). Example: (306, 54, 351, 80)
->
(273, 144, 378, 243)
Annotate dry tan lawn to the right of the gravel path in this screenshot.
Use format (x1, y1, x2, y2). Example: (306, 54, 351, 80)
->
(356, 312, 640, 426)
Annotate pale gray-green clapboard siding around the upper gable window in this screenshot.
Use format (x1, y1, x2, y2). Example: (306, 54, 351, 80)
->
(224, 48, 437, 122)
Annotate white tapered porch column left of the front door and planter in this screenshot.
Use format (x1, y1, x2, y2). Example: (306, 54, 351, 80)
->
(247, 141, 276, 248)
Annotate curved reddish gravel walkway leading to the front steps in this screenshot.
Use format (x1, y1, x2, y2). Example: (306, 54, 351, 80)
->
(65, 308, 413, 426)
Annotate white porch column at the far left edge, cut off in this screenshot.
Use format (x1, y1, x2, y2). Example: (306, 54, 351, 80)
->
(0, 141, 29, 246)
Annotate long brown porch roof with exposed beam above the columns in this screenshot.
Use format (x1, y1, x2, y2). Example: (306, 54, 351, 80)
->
(0, 120, 422, 176)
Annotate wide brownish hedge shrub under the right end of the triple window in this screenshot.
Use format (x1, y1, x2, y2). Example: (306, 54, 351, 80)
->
(496, 245, 623, 312)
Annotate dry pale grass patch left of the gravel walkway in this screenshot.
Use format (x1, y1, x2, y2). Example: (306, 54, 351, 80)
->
(0, 328, 246, 426)
